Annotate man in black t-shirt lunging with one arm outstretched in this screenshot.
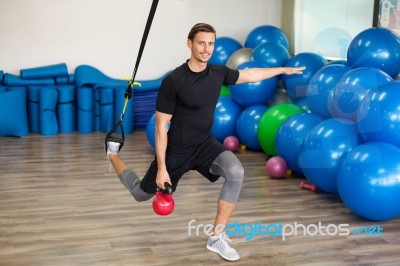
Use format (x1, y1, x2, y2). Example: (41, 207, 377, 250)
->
(107, 23, 304, 261)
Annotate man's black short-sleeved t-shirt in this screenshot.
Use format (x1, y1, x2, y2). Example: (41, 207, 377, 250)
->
(156, 63, 239, 153)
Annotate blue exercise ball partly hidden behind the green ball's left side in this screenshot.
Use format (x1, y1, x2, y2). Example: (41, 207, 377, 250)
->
(236, 105, 268, 151)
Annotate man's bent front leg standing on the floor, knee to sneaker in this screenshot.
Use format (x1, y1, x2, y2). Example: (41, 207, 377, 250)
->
(207, 151, 244, 261)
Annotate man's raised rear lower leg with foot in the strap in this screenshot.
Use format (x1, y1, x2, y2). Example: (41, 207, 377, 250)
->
(107, 142, 154, 201)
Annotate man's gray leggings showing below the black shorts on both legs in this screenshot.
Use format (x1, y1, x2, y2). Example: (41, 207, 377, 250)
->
(119, 151, 244, 203)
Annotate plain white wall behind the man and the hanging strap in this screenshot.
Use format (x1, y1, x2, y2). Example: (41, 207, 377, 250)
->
(0, 0, 281, 80)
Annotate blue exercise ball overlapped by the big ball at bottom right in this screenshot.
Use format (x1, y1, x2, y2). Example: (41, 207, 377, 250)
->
(298, 118, 361, 193)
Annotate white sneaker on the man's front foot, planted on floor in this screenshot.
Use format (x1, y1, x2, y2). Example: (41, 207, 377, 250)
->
(207, 233, 240, 261)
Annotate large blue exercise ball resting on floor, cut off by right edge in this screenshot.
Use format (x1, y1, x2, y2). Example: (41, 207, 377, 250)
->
(337, 142, 400, 221)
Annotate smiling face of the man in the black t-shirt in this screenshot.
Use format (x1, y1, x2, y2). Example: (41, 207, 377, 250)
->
(188, 32, 215, 63)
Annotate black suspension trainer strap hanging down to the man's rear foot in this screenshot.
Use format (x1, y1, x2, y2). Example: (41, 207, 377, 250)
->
(105, 0, 158, 150)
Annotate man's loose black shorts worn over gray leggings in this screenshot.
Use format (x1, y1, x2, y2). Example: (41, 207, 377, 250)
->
(140, 136, 227, 194)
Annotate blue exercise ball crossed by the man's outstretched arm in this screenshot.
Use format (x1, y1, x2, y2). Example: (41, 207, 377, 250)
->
(229, 61, 278, 107)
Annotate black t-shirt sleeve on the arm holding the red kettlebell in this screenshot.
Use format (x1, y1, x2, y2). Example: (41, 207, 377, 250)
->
(156, 76, 177, 115)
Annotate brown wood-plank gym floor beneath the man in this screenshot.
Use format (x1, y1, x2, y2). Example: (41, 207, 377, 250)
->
(0, 131, 400, 266)
